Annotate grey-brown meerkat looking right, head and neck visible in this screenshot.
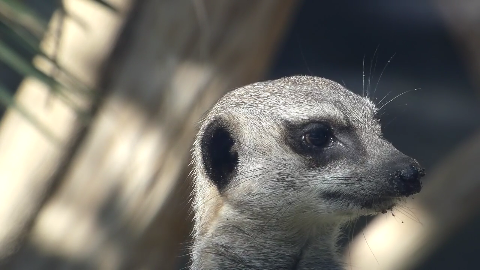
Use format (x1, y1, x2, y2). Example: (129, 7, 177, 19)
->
(191, 76, 424, 269)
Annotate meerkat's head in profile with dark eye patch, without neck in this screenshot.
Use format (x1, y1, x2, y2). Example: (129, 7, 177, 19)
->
(194, 76, 424, 234)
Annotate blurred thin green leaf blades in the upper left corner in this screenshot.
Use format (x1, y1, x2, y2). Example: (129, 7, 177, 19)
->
(0, 0, 117, 141)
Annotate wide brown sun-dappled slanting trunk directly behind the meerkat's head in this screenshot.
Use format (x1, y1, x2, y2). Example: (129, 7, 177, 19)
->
(0, 0, 297, 269)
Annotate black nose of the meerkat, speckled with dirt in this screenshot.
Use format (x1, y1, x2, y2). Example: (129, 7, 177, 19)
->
(395, 163, 425, 196)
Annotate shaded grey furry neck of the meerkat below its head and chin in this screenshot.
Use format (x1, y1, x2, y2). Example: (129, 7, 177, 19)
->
(192, 210, 342, 269)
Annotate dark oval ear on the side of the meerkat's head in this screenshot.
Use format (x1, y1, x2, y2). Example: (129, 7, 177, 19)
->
(201, 119, 238, 191)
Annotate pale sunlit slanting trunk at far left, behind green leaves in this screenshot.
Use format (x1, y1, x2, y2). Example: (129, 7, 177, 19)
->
(0, 0, 133, 264)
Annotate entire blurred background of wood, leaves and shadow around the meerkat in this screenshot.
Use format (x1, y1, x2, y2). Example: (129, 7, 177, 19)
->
(0, 0, 480, 269)
